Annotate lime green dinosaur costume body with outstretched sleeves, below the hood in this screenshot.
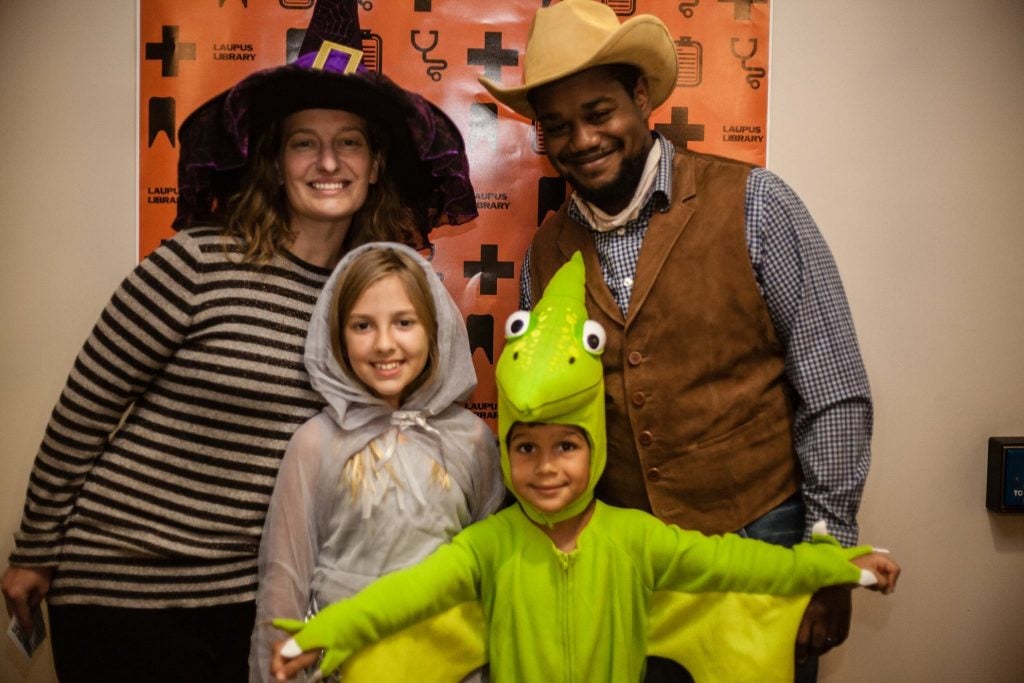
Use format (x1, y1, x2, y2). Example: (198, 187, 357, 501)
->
(275, 503, 867, 683)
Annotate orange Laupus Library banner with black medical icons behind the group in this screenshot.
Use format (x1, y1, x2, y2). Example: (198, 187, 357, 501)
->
(138, 0, 770, 426)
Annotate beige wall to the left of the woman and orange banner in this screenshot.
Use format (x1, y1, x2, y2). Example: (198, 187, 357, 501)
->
(0, 0, 135, 683)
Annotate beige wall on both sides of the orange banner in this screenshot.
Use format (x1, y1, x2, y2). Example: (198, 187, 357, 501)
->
(0, 0, 1024, 683)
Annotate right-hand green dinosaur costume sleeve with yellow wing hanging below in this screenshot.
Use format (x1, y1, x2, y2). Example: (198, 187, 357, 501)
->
(612, 509, 870, 683)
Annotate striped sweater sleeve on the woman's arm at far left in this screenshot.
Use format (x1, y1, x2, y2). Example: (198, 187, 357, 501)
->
(10, 234, 202, 566)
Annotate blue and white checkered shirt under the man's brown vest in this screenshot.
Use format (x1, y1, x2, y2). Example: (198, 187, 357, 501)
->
(519, 133, 872, 546)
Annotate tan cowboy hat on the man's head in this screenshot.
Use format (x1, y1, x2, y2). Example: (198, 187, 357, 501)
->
(479, 0, 678, 119)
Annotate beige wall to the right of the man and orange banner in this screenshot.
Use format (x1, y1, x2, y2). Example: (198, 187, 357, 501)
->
(768, 0, 1024, 682)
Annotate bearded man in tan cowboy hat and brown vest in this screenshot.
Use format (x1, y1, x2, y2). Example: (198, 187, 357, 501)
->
(480, 0, 871, 680)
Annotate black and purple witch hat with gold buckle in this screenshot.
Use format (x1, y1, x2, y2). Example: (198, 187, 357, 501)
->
(173, 0, 477, 240)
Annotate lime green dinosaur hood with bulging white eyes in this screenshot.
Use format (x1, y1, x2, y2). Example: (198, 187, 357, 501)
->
(496, 252, 607, 525)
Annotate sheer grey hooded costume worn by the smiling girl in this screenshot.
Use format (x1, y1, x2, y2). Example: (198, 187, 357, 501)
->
(249, 243, 504, 681)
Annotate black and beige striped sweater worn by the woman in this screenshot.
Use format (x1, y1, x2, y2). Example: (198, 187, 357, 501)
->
(10, 228, 330, 607)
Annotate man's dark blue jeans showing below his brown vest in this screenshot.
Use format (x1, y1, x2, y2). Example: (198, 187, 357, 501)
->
(644, 494, 818, 683)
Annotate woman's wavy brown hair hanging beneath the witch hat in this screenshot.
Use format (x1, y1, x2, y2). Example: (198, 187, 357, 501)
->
(225, 111, 417, 265)
